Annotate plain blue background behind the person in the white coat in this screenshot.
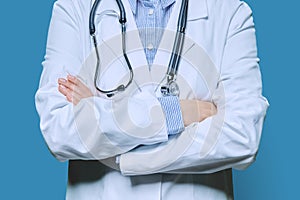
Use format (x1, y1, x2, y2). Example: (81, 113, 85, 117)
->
(0, 0, 300, 200)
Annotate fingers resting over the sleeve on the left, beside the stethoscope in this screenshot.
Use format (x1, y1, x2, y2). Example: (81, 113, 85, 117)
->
(58, 75, 94, 105)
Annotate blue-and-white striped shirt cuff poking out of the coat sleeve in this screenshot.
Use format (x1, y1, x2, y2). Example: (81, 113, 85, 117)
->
(158, 95, 184, 135)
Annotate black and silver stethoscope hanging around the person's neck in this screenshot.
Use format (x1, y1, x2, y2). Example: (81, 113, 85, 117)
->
(89, 0, 188, 97)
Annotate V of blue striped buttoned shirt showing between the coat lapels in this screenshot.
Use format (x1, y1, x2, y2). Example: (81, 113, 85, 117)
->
(129, 0, 175, 66)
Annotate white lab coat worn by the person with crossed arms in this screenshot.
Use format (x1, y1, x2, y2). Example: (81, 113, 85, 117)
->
(36, 0, 268, 200)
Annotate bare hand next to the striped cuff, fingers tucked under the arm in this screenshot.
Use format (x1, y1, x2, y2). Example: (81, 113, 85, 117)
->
(180, 100, 217, 126)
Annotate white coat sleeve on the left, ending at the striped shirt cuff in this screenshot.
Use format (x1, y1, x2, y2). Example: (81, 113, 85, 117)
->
(35, 0, 168, 161)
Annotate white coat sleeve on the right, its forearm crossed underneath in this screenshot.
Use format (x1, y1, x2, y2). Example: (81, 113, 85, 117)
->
(120, 3, 268, 175)
